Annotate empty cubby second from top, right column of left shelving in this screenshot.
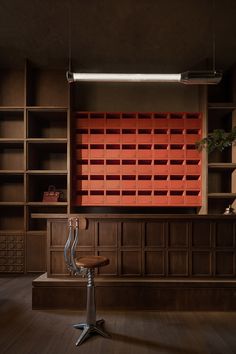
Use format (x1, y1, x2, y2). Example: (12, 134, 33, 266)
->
(27, 109, 67, 139)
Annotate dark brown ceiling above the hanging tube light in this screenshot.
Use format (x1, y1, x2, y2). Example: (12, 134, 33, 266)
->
(0, 0, 236, 72)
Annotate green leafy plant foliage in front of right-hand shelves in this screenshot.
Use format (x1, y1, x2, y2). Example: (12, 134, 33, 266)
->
(196, 127, 236, 153)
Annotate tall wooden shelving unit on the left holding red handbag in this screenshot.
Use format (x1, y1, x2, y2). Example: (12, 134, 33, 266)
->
(0, 62, 70, 273)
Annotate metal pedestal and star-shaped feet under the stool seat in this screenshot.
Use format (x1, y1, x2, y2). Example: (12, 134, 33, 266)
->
(74, 268, 110, 346)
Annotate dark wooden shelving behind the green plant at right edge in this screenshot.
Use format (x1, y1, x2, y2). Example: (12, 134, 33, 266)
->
(208, 72, 236, 214)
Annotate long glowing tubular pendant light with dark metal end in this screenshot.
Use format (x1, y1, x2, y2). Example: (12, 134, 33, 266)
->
(66, 71, 222, 85)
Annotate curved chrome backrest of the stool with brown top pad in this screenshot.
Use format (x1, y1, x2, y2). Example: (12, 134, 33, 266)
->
(64, 217, 87, 275)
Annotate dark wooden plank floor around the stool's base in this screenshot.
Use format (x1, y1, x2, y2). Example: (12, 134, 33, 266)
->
(0, 276, 236, 354)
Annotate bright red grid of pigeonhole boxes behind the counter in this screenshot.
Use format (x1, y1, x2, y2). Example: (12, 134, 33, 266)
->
(74, 112, 202, 206)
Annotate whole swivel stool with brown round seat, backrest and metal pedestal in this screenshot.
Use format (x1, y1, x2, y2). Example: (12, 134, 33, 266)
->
(64, 218, 110, 346)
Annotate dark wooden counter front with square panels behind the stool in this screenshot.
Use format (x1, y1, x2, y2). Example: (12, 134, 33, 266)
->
(45, 218, 235, 278)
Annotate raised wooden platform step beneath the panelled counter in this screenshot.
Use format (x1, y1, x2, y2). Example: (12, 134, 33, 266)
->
(32, 273, 236, 311)
